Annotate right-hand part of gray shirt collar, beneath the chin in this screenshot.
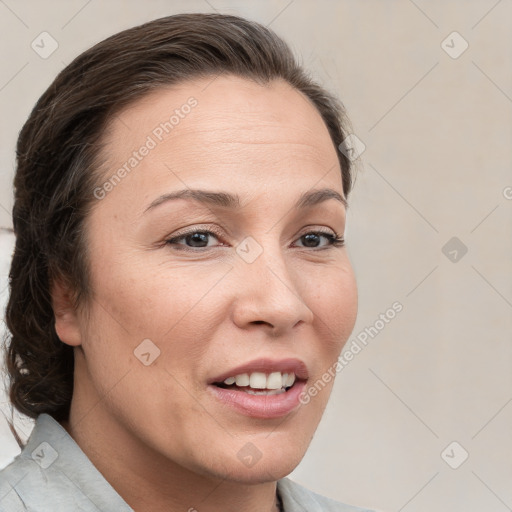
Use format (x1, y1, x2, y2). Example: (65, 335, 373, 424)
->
(277, 478, 372, 512)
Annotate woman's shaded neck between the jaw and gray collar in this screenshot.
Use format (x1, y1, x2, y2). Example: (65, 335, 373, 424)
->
(61, 356, 279, 512)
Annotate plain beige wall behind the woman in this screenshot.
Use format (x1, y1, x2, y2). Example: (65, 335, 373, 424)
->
(0, 0, 512, 512)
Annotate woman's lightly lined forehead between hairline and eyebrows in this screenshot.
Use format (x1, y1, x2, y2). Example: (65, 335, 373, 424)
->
(95, 76, 342, 213)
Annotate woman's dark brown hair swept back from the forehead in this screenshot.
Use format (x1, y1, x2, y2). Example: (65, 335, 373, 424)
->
(6, 13, 352, 436)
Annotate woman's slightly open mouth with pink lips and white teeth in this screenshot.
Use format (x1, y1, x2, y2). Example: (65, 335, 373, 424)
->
(208, 359, 308, 419)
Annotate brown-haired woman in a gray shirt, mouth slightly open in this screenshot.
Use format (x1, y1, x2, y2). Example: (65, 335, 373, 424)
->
(0, 14, 376, 512)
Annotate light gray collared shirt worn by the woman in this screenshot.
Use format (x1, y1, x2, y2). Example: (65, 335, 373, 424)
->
(0, 414, 370, 512)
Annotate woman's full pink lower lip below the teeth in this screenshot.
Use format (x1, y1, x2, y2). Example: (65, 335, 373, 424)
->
(208, 381, 306, 419)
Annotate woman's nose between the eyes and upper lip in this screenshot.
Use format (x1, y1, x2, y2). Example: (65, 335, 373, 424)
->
(233, 243, 313, 337)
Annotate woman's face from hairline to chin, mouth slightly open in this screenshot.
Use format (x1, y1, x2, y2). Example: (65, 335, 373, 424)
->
(76, 76, 357, 483)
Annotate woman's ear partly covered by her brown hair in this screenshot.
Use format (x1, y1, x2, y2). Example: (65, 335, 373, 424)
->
(51, 279, 82, 347)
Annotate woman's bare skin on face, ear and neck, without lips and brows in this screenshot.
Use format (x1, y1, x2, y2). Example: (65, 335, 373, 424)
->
(53, 76, 357, 512)
